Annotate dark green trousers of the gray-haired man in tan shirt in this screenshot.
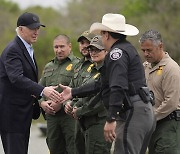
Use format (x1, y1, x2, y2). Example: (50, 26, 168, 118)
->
(149, 119, 180, 154)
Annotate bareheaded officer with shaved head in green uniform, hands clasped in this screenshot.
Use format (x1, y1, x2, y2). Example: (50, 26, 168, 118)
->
(39, 35, 79, 154)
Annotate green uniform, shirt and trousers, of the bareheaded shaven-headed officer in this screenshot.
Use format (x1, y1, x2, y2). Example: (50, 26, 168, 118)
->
(39, 54, 79, 154)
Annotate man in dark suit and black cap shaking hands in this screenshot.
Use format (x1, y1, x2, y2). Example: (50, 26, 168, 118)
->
(0, 13, 60, 154)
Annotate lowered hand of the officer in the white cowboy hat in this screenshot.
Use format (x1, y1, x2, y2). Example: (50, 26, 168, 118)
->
(104, 121, 116, 142)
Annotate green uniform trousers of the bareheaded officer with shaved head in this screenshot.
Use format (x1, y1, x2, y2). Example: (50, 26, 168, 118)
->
(46, 112, 75, 154)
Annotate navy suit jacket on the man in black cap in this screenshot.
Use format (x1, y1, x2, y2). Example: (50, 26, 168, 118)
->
(0, 36, 44, 133)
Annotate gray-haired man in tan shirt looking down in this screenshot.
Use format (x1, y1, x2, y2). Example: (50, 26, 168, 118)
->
(139, 30, 180, 154)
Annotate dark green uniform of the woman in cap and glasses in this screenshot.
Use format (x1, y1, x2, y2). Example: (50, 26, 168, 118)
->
(76, 62, 111, 154)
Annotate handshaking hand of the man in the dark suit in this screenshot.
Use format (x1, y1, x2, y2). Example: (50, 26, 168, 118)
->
(43, 86, 63, 102)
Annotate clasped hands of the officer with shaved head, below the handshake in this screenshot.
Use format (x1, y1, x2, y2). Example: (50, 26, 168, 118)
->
(41, 100, 56, 115)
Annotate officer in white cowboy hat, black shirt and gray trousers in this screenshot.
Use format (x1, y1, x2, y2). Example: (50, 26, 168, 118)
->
(61, 13, 155, 154)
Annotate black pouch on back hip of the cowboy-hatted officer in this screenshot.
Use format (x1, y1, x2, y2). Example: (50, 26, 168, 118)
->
(139, 87, 151, 104)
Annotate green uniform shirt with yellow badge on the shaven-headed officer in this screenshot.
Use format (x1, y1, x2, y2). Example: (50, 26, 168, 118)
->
(39, 53, 79, 101)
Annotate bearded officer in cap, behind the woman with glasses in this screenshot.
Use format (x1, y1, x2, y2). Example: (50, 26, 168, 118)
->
(65, 31, 94, 154)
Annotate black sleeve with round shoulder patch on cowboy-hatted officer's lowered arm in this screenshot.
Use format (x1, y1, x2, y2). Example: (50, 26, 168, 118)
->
(106, 48, 128, 115)
